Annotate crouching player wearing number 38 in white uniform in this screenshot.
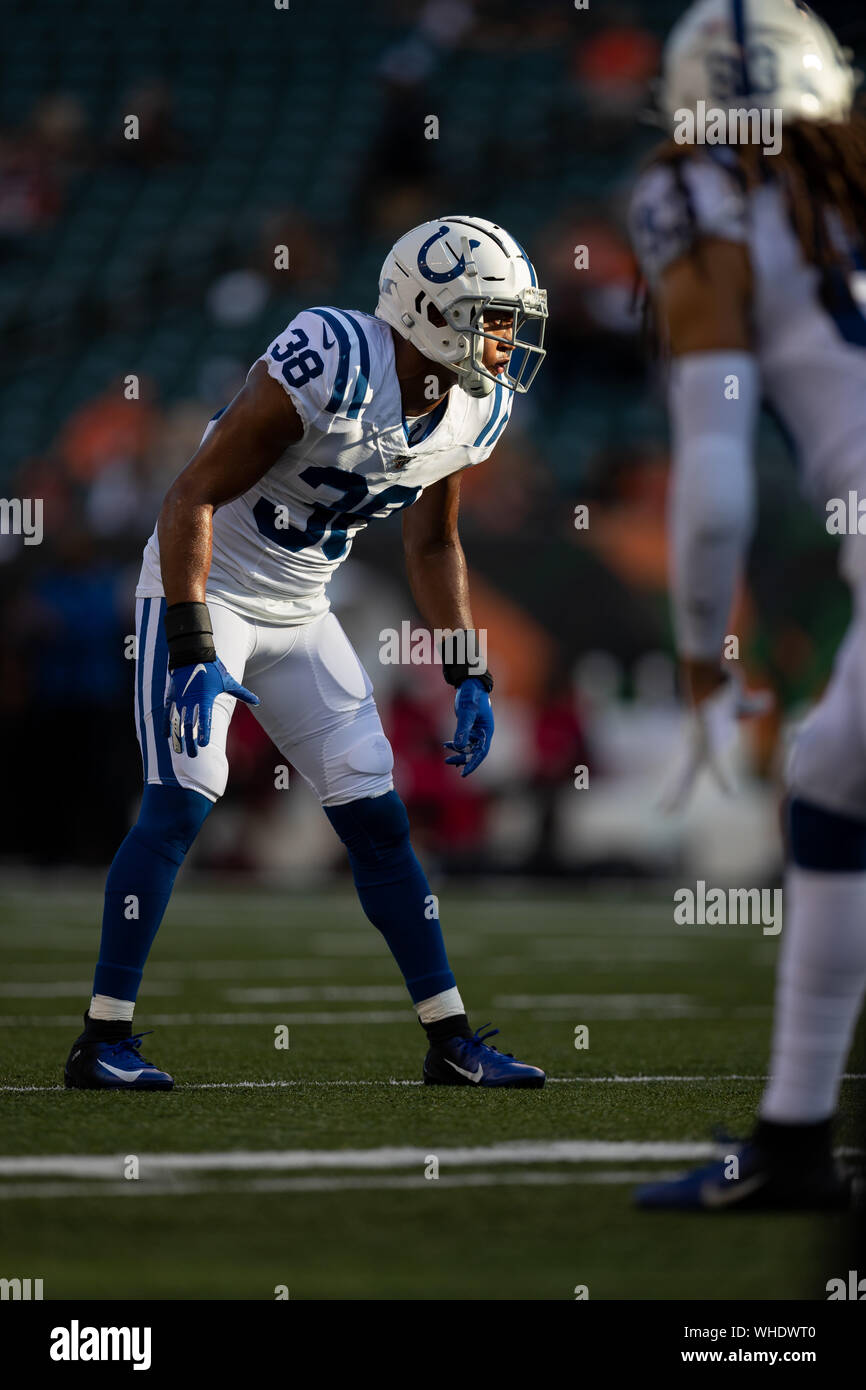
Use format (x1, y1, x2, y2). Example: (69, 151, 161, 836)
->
(65, 217, 548, 1090)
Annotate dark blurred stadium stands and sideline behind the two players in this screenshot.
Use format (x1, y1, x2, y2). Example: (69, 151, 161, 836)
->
(0, 0, 861, 874)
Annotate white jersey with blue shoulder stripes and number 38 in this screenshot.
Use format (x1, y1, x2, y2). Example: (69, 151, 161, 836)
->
(136, 309, 513, 624)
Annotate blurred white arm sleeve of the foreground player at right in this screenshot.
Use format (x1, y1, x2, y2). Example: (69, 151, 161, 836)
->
(669, 352, 760, 660)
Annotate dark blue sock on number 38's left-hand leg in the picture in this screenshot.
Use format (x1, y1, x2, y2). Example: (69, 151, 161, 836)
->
(93, 785, 213, 999)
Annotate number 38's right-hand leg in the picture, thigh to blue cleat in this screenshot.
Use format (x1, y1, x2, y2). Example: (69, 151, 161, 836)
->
(250, 613, 544, 1086)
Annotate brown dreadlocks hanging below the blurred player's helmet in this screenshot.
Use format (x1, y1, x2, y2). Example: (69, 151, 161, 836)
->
(635, 113, 866, 353)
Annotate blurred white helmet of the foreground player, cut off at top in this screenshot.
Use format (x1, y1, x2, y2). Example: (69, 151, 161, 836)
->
(660, 0, 859, 124)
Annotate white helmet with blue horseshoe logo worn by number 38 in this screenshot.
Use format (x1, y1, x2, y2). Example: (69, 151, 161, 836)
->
(375, 217, 548, 396)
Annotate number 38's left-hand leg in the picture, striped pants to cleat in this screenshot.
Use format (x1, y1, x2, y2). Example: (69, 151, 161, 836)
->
(67, 598, 254, 1090)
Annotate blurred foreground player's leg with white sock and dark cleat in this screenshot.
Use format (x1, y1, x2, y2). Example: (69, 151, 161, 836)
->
(638, 612, 866, 1209)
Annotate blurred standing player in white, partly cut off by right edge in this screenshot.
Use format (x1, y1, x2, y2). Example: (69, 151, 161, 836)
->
(631, 0, 866, 1209)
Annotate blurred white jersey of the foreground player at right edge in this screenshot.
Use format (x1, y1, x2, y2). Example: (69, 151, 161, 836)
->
(630, 146, 866, 505)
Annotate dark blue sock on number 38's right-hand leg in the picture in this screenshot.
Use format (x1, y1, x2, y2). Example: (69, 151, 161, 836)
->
(322, 791, 455, 1004)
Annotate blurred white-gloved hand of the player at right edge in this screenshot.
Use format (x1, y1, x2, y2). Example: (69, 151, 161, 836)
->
(659, 670, 773, 813)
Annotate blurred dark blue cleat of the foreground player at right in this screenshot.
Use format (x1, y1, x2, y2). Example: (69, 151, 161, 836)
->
(634, 1141, 852, 1212)
